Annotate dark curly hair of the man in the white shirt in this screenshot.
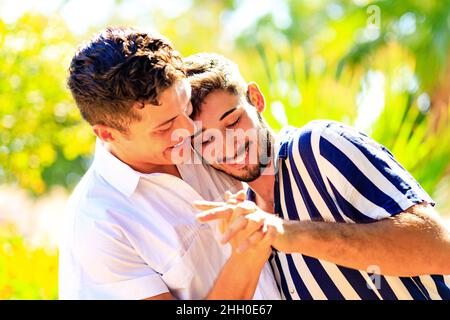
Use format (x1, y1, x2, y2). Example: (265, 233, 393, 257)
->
(67, 27, 185, 132)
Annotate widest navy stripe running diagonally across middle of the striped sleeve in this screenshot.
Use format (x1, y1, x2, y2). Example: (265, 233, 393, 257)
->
(319, 139, 403, 215)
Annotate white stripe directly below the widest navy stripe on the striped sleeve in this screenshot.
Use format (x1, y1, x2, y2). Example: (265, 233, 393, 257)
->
(322, 158, 391, 220)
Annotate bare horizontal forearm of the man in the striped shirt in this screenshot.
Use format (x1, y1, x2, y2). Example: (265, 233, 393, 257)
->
(275, 213, 450, 276)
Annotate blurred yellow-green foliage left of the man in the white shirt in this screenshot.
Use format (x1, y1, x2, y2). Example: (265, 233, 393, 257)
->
(0, 14, 93, 194)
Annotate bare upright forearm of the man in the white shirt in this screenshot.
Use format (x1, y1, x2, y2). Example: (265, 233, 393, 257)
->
(207, 253, 267, 300)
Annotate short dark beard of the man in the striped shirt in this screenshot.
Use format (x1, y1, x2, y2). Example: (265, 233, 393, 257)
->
(213, 113, 273, 182)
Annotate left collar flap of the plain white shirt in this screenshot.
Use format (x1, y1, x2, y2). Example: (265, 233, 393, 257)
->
(93, 139, 141, 197)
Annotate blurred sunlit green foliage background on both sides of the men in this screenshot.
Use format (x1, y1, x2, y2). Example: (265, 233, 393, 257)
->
(0, 0, 450, 200)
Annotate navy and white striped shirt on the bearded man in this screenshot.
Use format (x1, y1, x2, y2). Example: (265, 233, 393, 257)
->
(251, 121, 450, 300)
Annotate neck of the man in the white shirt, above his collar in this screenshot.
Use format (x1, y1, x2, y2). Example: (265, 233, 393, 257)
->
(103, 143, 181, 179)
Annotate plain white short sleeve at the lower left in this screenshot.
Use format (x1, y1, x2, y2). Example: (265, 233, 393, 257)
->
(74, 210, 169, 300)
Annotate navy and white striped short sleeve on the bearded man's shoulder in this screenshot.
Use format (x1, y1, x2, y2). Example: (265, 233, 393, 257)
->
(319, 122, 434, 222)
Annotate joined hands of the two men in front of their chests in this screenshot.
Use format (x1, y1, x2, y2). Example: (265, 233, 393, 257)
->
(194, 191, 284, 253)
